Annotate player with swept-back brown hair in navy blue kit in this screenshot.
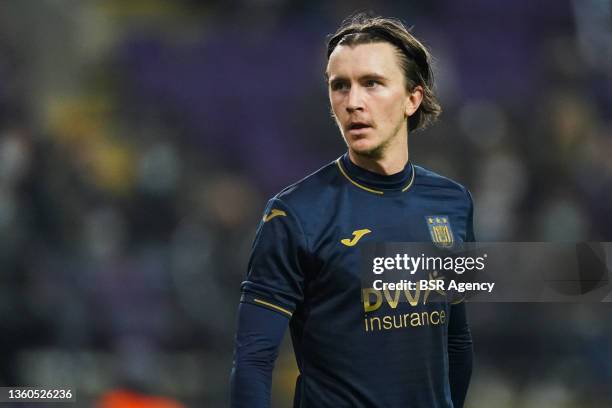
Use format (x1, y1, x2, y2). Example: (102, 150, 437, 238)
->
(231, 15, 473, 408)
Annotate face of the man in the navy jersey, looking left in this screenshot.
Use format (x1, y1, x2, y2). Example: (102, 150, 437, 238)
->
(326, 42, 420, 159)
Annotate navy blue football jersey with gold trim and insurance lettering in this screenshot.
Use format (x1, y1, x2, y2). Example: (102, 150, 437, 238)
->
(241, 154, 473, 408)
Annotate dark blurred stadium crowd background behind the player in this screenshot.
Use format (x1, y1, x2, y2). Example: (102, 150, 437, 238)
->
(0, 0, 612, 408)
